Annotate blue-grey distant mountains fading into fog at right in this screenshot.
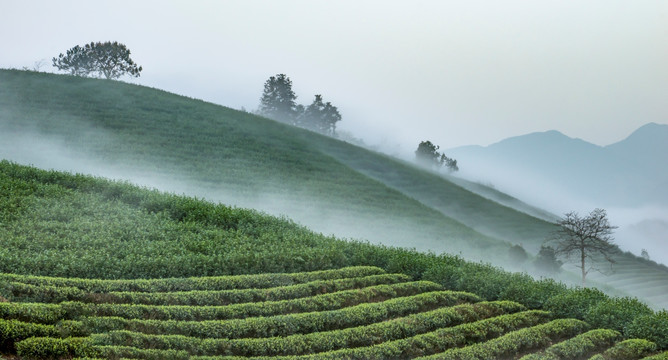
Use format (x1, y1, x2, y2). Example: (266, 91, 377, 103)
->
(446, 123, 668, 207)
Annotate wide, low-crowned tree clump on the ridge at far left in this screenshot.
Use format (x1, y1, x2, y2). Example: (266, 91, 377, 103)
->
(52, 41, 143, 79)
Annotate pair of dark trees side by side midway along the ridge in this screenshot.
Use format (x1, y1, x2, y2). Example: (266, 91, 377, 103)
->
(258, 74, 341, 136)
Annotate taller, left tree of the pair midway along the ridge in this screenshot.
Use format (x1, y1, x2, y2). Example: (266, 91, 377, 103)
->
(258, 74, 300, 125)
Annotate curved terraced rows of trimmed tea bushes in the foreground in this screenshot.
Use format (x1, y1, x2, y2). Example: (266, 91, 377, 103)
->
(0, 266, 668, 360)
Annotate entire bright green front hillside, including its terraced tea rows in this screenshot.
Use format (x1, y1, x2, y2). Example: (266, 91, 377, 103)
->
(0, 161, 668, 359)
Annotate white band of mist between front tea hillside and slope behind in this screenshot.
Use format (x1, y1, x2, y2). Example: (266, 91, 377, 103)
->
(0, 128, 490, 261)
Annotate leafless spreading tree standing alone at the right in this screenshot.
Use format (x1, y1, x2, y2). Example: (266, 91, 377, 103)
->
(550, 209, 618, 287)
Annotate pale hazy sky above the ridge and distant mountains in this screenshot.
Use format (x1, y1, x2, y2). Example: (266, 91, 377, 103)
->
(0, 0, 668, 154)
